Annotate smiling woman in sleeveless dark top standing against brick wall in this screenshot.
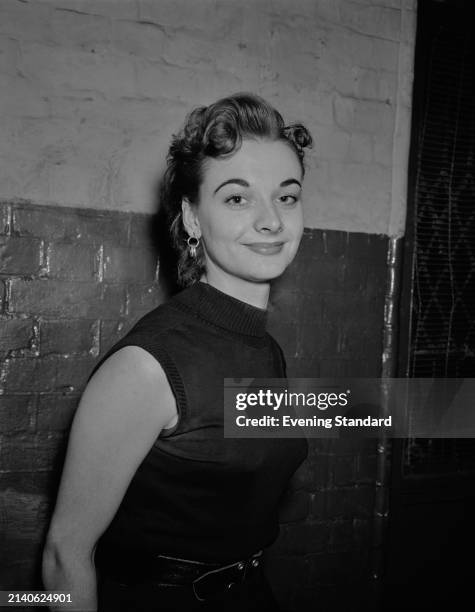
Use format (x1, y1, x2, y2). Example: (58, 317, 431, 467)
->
(43, 94, 311, 612)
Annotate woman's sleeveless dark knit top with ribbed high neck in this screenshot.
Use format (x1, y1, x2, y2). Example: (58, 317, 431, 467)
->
(96, 282, 307, 562)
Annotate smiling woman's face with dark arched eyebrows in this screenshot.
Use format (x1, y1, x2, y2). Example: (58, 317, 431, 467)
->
(183, 139, 303, 284)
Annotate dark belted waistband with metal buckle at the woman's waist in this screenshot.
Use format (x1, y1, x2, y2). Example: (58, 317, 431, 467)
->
(95, 550, 263, 600)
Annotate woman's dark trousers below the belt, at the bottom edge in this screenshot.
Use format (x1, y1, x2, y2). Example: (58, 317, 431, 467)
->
(98, 569, 280, 612)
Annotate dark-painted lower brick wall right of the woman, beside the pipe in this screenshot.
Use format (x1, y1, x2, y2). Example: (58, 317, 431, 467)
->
(269, 229, 388, 612)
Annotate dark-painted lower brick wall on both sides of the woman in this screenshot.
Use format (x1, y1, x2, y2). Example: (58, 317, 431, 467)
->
(0, 202, 387, 612)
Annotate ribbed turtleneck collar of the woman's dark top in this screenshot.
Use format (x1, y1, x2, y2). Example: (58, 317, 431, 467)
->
(174, 281, 267, 336)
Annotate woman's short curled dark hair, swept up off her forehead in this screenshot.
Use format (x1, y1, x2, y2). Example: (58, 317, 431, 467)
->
(161, 93, 312, 286)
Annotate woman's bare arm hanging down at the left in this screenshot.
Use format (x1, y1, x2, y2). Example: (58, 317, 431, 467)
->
(43, 346, 177, 611)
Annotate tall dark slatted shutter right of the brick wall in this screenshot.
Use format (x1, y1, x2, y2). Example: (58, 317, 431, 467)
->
(400, 0, 475, 476)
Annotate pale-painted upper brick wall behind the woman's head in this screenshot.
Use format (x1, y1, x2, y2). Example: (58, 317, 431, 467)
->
(0, 0, 416, 235)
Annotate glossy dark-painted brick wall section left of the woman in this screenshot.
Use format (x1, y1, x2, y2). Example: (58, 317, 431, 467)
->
(0, 203, 161, 588)
